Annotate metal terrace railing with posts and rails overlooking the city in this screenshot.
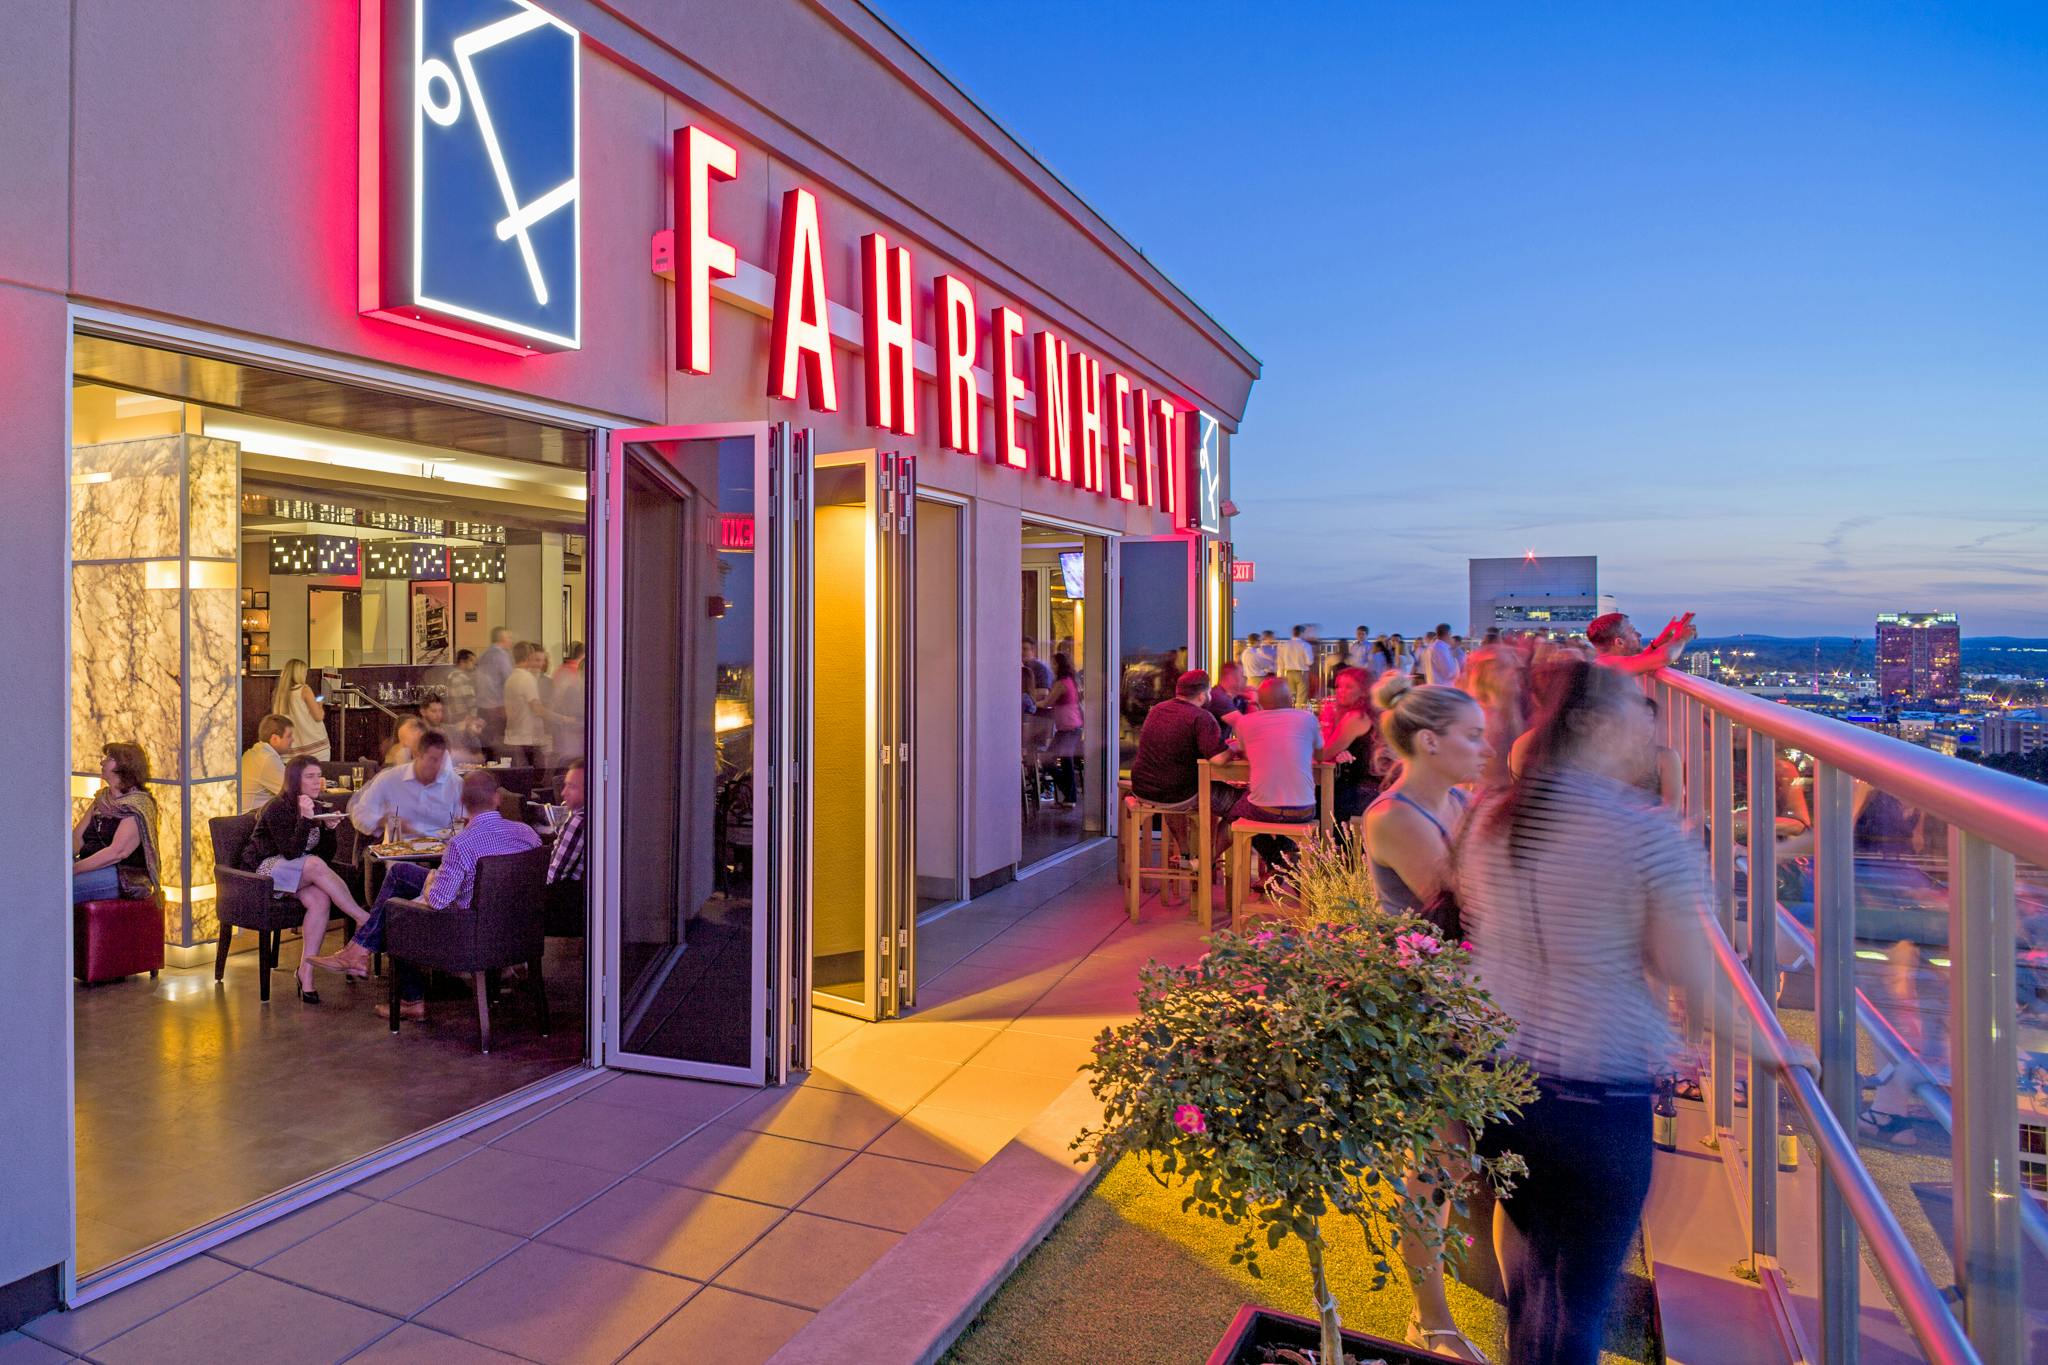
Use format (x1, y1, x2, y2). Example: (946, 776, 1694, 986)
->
(1657, 669, 2048, 1365)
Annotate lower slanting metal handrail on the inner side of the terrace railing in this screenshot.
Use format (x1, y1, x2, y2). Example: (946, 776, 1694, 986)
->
(1710, 916, 1980, 1365)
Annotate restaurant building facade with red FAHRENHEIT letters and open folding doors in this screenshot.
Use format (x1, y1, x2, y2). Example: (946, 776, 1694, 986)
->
(0, 0, 1257, 1328)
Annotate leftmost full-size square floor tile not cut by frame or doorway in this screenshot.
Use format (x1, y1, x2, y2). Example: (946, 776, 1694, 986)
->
(262, 1203, 520, 1318)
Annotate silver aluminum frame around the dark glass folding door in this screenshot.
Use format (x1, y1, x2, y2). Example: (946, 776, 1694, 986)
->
(590, 422, 807, 1085)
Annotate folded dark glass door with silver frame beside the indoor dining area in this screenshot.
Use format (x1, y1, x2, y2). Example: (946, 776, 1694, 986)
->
(594, 424, 809, 1085)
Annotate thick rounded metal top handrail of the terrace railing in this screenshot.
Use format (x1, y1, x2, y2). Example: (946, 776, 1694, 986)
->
(1657, 669, 2048, 866)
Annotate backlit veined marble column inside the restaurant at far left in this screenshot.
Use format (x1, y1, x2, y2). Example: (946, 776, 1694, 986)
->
(72, 436, 242, 949)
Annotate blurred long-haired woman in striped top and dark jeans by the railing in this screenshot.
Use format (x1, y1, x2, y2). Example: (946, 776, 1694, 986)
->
(1458, 657, 1712, 1365)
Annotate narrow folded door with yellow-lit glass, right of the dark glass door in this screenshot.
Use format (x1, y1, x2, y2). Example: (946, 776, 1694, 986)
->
(811, 450, 918, 1019)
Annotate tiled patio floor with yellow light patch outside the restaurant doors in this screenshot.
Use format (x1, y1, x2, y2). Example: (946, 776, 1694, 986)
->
(0, 845, 1202, 1365)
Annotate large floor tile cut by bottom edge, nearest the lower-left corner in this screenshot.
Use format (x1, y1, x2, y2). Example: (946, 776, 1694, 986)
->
(92, 1271, 397, 1365)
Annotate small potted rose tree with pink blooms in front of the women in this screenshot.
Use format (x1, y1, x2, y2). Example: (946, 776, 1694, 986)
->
(1075, 896, 1534, 1365)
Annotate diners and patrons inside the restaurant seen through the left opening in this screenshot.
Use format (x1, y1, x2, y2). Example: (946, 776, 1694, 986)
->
(72, 628, 588, 1031)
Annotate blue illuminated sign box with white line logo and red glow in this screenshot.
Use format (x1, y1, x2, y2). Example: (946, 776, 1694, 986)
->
(360, 0, 584, 354)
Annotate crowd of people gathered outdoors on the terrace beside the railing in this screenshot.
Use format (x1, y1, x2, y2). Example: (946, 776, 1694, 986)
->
(1130, 614, 1712, 1365)
